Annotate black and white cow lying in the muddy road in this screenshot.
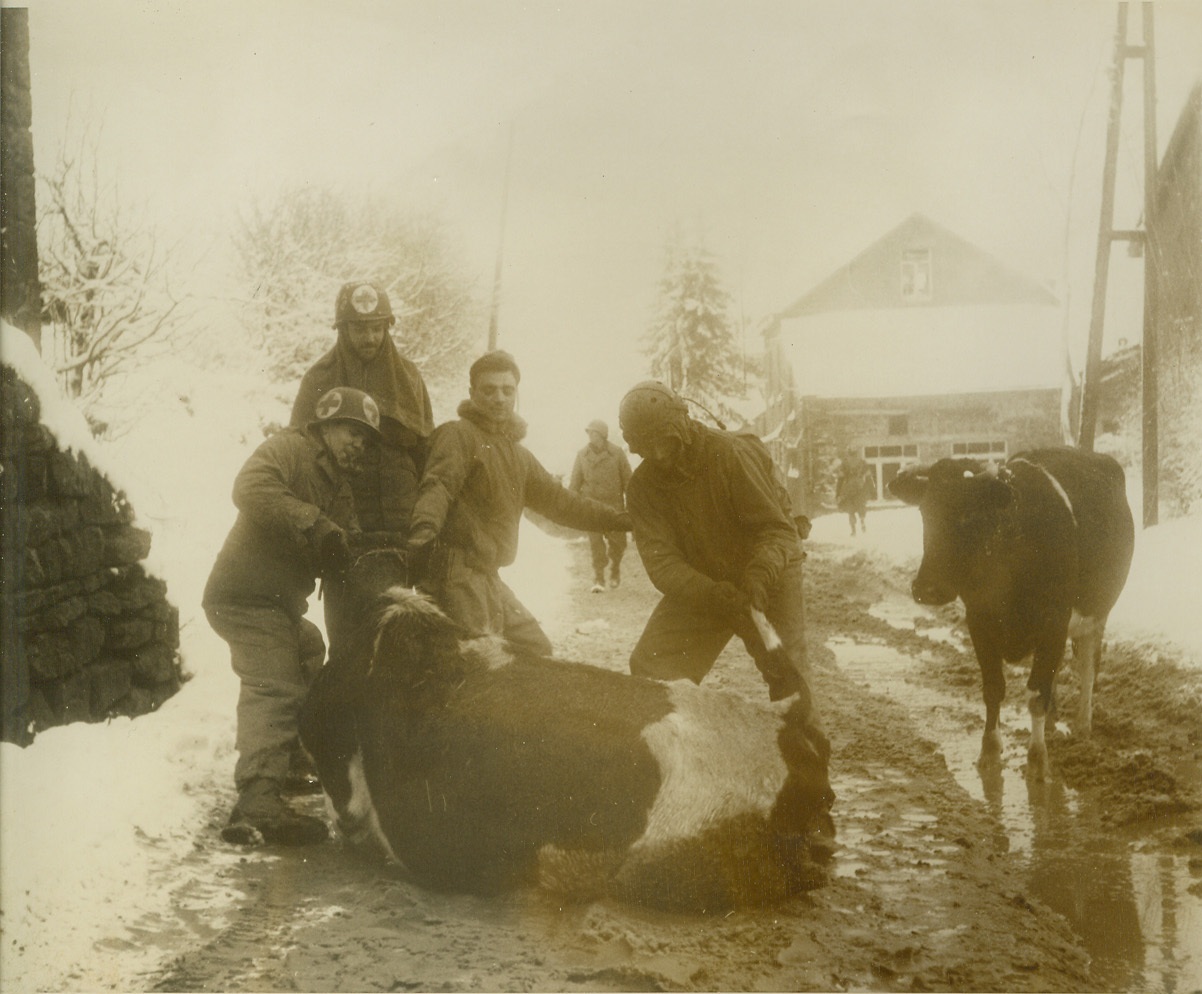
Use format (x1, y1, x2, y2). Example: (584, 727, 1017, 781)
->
(301, 552, 833, 911)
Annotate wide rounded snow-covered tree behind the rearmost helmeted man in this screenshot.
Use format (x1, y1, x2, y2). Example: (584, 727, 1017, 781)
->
(234, 188, 483, 392)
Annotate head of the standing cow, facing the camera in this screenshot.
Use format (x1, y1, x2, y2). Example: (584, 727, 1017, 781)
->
(889, 459, 1014, 606)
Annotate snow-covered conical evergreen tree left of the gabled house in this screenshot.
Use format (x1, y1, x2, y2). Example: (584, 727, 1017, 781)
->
(643, 232, 746, 421)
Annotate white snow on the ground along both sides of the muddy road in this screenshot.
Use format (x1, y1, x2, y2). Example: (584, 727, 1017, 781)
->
(0, 328, 1202, 990)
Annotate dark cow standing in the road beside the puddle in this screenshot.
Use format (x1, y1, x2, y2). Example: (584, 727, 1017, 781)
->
(889, 448, 1135, 776)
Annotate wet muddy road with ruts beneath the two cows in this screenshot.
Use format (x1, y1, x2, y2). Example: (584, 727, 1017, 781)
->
(144, 542, 1202, 992)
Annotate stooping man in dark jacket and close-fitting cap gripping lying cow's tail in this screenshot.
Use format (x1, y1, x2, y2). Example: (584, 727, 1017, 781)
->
(619, 380, 831, 841)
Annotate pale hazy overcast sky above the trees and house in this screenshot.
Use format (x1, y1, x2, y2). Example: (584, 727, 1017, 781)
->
(21, 0, 1202, 462)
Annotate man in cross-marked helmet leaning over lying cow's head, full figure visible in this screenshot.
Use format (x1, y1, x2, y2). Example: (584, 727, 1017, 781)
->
(203, 387, 380, 845)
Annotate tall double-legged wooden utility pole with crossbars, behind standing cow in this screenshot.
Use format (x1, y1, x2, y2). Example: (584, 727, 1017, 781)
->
(1077, 0, 1160, 528)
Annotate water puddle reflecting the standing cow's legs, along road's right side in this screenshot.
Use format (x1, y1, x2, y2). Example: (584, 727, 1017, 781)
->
(827, 629, 1202, 992)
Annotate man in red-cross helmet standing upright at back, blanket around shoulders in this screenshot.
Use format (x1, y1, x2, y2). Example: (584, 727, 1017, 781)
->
(291, 280, 434, 543)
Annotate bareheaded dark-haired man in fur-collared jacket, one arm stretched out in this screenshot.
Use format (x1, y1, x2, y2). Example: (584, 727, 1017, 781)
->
(409, 350, 630, 655)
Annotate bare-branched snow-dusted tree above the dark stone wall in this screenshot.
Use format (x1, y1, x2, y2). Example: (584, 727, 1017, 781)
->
(37, 121, 185, 430)
